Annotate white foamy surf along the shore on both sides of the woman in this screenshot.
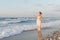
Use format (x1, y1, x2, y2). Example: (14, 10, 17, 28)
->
(0, 20, 60, 38)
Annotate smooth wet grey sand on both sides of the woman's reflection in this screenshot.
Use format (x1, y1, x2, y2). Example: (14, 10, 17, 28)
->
(0, 28, 58, 40)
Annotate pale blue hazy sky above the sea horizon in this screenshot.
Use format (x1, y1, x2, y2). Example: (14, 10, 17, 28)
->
(0, 0, 60, 17)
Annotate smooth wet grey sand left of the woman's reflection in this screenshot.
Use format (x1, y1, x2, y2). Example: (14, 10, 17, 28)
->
(0, 30, 37, 40)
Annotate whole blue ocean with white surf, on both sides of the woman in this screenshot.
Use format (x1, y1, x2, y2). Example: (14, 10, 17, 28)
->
(0, 17, 60, 39)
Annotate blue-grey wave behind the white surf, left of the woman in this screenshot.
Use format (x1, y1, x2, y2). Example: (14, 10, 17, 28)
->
(0, 19, 35, 25)
